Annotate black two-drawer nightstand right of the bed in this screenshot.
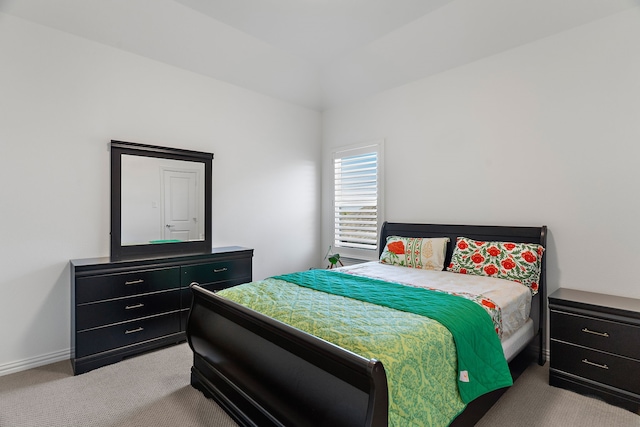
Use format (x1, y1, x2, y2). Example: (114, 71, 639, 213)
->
(549, 289, 640, 414)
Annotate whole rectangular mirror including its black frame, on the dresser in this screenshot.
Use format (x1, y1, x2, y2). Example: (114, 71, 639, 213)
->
(110, 141, 213, 259)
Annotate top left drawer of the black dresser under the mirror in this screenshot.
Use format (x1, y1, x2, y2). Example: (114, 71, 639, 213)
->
(75, 267, 180, 304)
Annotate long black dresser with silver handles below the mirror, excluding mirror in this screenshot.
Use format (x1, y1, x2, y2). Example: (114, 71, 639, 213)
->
(70, 246, 253, 374)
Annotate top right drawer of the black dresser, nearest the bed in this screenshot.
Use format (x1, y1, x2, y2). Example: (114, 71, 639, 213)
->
(182, 258, 251, 287)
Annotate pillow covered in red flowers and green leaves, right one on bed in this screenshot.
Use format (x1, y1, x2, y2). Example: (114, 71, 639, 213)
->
(447, 237, 544, 295)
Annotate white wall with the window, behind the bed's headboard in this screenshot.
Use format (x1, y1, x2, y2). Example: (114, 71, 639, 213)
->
(323, 8, 640, 298)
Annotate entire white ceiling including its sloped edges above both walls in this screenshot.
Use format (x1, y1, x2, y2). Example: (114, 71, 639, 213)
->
(0, 0, 640, 110)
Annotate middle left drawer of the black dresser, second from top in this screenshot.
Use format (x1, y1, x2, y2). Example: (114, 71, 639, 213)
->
(76, 289, 180, 332)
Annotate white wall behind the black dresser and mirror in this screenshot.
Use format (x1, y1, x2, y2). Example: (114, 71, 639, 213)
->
(0, 14, 320, 374)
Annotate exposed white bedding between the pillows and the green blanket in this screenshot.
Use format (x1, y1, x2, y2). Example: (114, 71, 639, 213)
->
(339, 261, 533, 342)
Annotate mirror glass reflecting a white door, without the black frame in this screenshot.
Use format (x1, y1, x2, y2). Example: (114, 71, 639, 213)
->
(121, 154, 205, 246)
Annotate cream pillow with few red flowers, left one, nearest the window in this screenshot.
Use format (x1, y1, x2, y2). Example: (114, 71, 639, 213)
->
(380, 236, 449, 271)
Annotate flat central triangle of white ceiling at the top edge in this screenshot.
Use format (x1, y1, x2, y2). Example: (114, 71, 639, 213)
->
(171, 0, 451, 65)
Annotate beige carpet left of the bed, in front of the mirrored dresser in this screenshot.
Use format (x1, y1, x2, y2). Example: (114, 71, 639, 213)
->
(0, 344, 236, 427)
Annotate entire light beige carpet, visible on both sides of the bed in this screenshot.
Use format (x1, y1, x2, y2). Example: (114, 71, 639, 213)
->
(0, 344, 640, 427)
